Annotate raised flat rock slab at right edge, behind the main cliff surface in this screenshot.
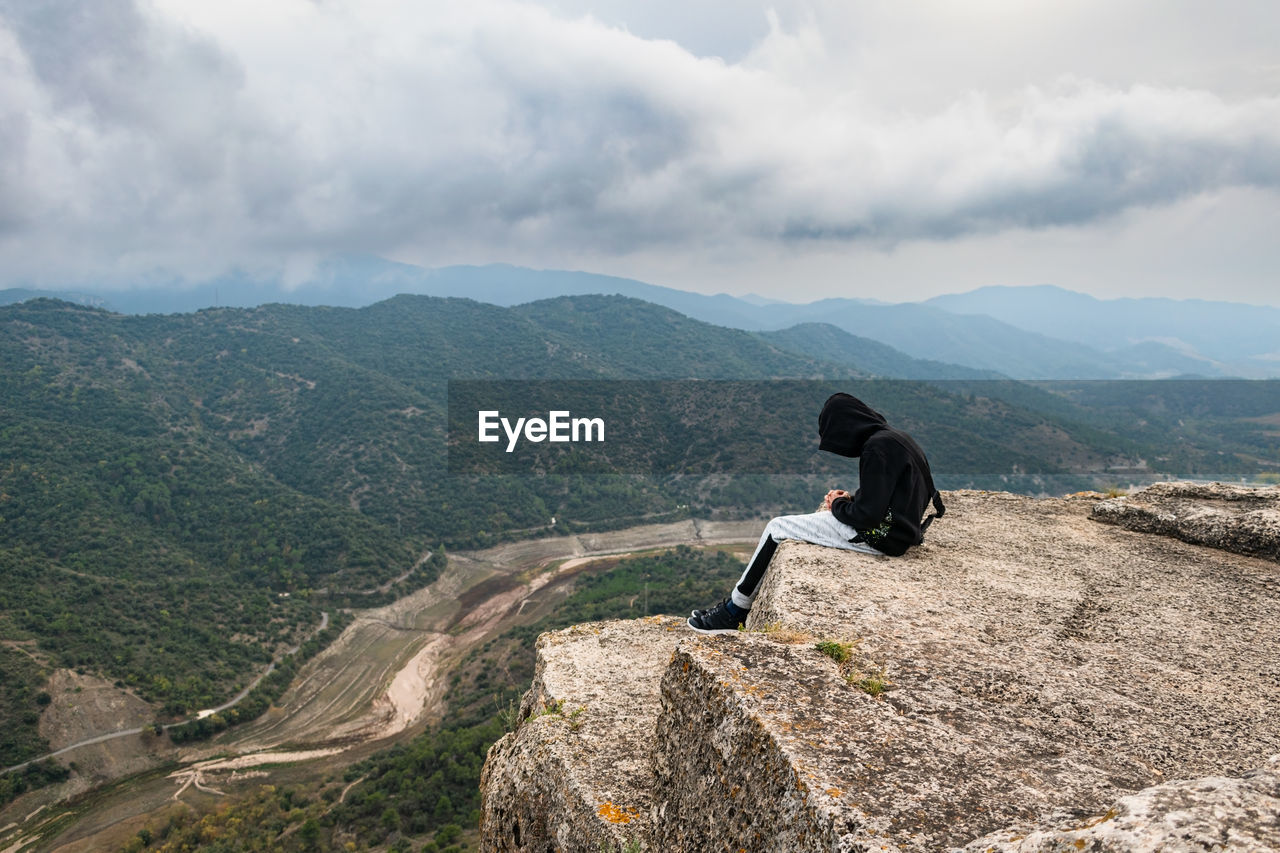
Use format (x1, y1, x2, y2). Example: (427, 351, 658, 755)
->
(1093, 483, 1280, 561)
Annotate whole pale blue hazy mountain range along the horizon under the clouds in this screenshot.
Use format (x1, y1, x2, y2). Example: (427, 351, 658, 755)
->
(7, 256, 1280, 379)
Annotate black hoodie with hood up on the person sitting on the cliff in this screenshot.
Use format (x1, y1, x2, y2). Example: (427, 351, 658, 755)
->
(818, 393, 946, 557)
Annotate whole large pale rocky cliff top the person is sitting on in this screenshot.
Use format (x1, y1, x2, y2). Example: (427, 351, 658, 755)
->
(481, 492, 1280, 853)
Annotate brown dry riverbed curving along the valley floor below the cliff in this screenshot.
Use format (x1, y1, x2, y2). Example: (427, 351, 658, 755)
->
(0, 521, 762, 853)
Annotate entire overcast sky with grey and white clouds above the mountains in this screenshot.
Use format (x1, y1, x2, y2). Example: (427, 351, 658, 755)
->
(0, 0, 1280, 305)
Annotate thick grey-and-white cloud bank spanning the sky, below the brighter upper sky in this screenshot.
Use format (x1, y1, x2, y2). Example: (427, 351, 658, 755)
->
(0, 0, 1280, 281)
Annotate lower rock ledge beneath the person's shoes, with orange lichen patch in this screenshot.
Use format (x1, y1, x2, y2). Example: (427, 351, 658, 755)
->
(480, 616, 685, 853)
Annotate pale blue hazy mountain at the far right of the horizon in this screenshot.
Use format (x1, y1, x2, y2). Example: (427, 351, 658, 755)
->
(927, 284, 1280, 374)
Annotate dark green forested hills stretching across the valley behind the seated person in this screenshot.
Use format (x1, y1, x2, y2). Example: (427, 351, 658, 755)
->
(0, 296, 1280, 765)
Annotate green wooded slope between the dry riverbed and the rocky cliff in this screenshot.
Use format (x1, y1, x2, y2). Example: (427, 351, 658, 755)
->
(124, 547, 741, 853)
